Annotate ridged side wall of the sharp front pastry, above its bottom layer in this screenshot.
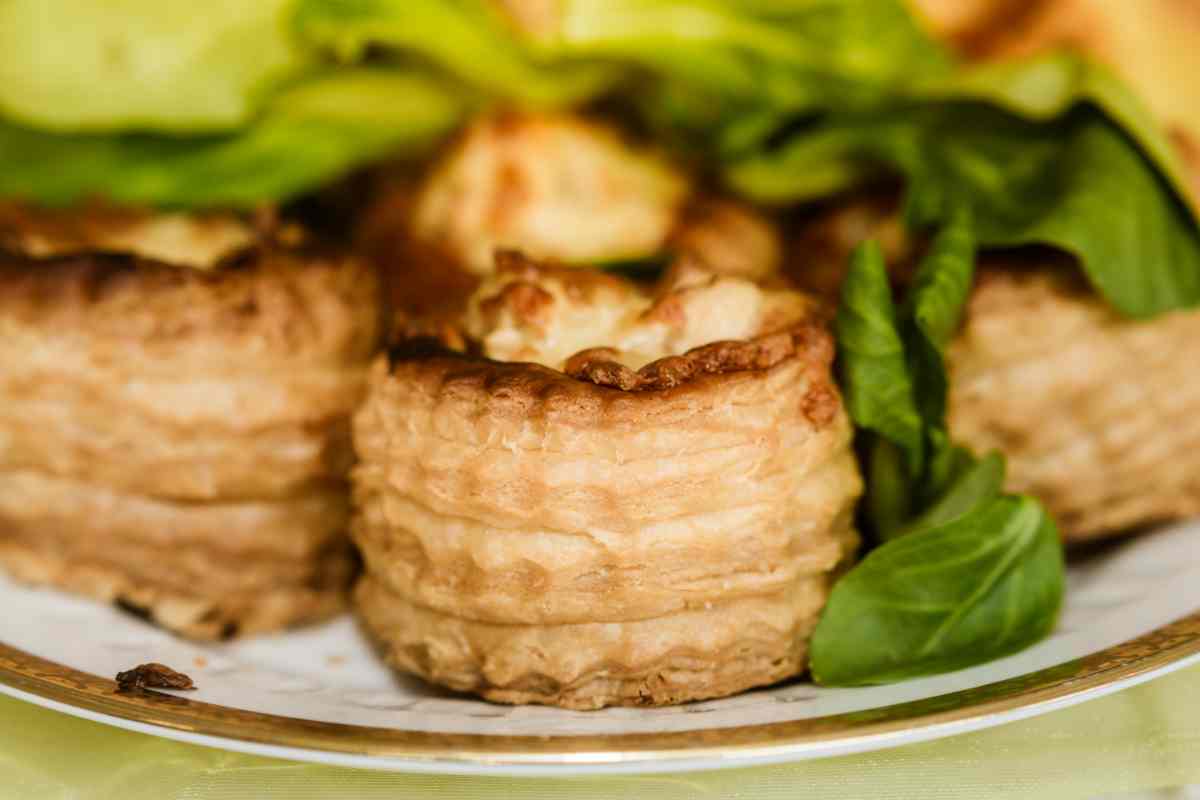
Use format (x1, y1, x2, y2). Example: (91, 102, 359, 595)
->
(354, 356, 860, 622)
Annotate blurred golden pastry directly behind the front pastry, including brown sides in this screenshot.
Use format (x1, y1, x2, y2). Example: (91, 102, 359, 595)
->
(359, 112, 782, 314)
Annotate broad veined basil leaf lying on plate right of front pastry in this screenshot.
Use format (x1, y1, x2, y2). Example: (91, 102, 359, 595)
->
(810, 497, 1063, 686)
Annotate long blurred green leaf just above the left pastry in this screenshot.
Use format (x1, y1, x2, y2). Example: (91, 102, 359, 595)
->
(0, 70, 467, 207)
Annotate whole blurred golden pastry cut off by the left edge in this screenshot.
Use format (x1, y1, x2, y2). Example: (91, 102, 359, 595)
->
(0, 212, 383, 637)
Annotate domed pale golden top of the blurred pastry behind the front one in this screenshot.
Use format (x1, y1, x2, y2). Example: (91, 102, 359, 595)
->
(413, 114, 690, 275)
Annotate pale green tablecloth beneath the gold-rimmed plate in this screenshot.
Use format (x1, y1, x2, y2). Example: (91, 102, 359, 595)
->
(0, 668, 1200, 800)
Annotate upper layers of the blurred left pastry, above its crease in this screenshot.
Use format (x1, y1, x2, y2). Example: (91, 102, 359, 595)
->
(0, 245, 382, 499)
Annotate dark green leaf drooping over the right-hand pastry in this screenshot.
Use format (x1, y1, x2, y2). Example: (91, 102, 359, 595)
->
(902, 107, 1200, 318)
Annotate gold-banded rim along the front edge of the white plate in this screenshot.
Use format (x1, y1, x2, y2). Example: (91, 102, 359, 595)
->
(0, 610, 1200, 771)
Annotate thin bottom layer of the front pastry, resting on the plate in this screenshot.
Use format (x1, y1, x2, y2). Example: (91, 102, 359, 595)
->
(355, 576, 828, 709)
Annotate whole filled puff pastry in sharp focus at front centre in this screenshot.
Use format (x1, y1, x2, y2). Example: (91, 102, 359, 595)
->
(353, 255, 860, 709)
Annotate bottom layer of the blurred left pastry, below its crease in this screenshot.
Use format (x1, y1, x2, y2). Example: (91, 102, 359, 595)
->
(0, 470, 354, 638)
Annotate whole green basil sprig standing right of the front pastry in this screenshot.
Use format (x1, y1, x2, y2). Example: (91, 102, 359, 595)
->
(810, 230, 1063, 685)
